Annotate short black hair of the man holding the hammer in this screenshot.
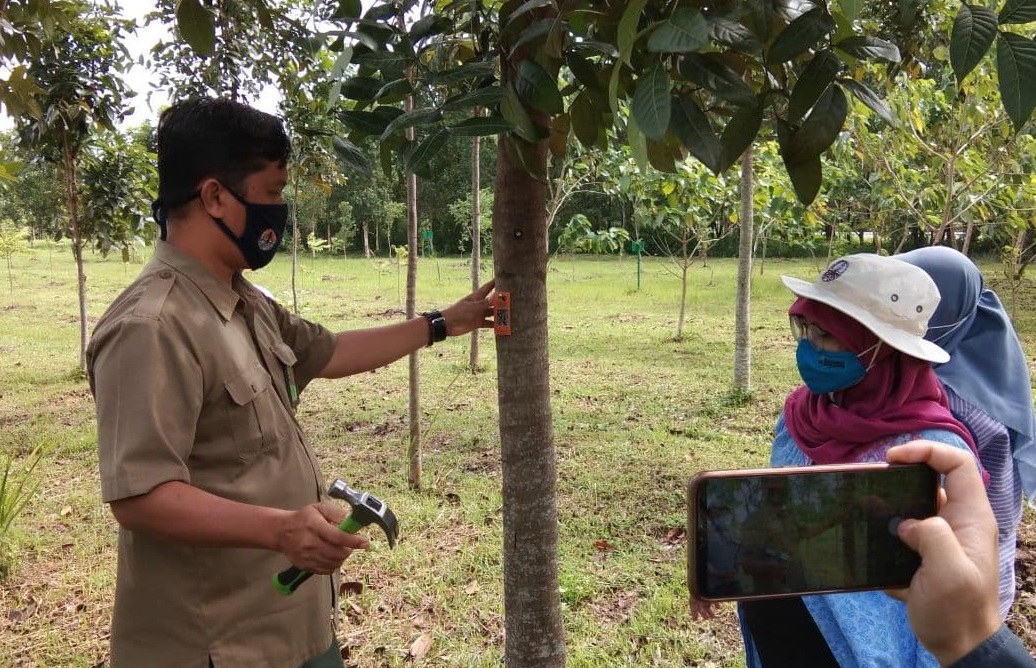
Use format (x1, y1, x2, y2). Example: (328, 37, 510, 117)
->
(155, 97, 291, 210)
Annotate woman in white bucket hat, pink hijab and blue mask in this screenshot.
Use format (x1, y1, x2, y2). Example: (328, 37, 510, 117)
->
(739, 254, 975, 668)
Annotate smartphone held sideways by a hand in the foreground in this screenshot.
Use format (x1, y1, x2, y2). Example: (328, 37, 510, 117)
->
(687, 463, 940, 601)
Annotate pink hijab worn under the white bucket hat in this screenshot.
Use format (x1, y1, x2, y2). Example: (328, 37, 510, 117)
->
(784, 297, 978, 464)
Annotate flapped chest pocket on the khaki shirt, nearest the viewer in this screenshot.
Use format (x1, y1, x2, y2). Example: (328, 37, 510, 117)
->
(224, 365, 277, 461)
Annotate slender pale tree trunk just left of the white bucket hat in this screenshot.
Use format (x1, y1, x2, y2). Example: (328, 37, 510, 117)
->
(733, 146, 755, 393)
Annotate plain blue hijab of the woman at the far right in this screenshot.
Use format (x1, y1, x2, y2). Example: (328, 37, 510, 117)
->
(895, 245, 1036, 499)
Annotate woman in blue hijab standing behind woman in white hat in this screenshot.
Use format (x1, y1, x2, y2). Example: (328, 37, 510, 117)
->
(895, 242, 1036, 619)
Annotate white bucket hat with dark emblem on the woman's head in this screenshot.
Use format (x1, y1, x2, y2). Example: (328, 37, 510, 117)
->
(781, 253, 950, 365)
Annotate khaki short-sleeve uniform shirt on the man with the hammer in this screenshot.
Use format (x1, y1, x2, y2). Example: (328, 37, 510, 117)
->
(87, 241, 335, 668)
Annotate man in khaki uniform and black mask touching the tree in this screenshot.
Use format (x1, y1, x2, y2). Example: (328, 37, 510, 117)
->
(88, 99, 492, 668)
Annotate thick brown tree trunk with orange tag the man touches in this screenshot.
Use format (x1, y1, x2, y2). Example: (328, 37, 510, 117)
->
(493, 29, 566, 668)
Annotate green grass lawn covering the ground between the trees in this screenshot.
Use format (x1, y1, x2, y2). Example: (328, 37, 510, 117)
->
(0, 248, 1036, 668)
